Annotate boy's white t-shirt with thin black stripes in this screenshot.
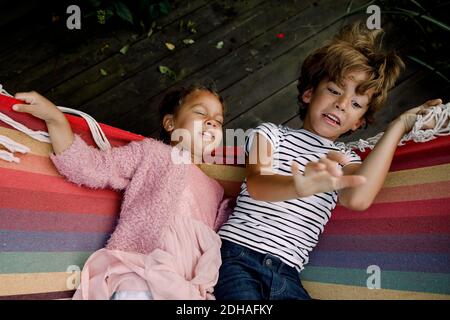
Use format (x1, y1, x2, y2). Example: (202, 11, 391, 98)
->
(219, 123, 361, 271)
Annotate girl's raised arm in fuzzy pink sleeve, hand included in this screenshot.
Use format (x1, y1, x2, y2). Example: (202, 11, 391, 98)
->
(13, 92, 147, 190)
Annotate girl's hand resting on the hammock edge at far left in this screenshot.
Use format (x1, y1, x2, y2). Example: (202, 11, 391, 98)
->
(13, 91, 64, 123)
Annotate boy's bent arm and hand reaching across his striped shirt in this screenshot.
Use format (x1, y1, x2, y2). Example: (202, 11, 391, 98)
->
(246, 134, 365, 201)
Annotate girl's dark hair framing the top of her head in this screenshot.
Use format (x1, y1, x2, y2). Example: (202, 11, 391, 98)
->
(159, 84, 225, 144)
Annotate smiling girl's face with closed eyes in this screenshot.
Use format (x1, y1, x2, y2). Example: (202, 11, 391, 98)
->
(163, 90, 224, 159)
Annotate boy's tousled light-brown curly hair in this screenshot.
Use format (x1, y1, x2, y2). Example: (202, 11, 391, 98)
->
(297, 22, 405, 124)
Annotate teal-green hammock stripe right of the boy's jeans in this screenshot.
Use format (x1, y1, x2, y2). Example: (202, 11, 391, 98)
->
(301, 267, 450, 294)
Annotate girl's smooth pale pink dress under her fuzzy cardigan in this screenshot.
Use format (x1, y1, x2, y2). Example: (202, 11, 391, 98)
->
(73, 165, 227, 300)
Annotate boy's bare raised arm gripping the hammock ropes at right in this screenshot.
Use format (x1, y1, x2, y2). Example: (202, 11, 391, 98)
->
(338, 99, 442, 211)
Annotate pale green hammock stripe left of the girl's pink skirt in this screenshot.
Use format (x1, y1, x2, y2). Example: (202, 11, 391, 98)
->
(0, 251, 92, 274)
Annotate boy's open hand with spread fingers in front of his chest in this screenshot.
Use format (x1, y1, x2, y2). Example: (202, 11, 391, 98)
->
(291, 151, 366, 197)
